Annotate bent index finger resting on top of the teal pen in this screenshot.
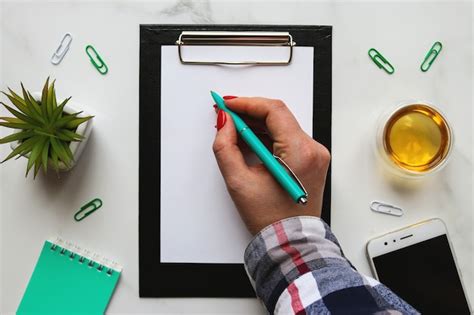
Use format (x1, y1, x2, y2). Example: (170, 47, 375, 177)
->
(225, 97, 303, 142)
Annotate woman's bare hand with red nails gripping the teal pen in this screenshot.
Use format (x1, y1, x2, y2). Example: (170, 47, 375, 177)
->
(213, 97, 330, 235)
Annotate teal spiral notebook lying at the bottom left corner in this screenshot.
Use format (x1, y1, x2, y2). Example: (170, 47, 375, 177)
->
(17, 238, 122, 314)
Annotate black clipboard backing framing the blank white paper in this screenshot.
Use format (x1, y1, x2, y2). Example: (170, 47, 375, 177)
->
(139, 25, 332, 297)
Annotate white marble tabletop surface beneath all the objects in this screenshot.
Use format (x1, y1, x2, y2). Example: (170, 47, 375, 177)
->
(0, 1, 474, 314)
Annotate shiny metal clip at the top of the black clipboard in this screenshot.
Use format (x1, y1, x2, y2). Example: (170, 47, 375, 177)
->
(176, 31, 296, 66)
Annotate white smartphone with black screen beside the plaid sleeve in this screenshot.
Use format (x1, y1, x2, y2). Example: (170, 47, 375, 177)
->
(367, 219, 471, 315)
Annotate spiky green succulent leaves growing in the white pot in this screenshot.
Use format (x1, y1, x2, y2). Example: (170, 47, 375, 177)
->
(0, 77, 93, 177)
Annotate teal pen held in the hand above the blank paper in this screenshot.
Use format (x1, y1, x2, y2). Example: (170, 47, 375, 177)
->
(211, 91, 308, 205)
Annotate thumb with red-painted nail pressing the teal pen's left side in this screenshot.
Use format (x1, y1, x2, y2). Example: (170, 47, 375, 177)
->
(212, 110, 250, 180)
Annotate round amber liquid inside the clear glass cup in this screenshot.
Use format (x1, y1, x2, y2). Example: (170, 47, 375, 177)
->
(383, 104, 451, 172)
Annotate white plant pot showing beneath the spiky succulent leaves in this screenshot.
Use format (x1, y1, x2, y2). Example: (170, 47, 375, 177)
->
(10, 92, 93, 171)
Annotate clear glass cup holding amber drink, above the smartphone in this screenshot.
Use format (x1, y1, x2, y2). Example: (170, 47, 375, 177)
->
(375, 101, 454, 178)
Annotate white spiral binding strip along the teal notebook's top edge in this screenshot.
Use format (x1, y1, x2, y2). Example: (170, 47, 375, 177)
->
(48, 237, 122, 276)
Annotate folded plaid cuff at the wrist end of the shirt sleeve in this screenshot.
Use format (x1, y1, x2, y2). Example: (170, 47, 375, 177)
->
(244, 216, 342, 312)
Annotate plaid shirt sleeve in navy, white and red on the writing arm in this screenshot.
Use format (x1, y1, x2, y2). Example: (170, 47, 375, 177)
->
(244, 216, 418, 314)
